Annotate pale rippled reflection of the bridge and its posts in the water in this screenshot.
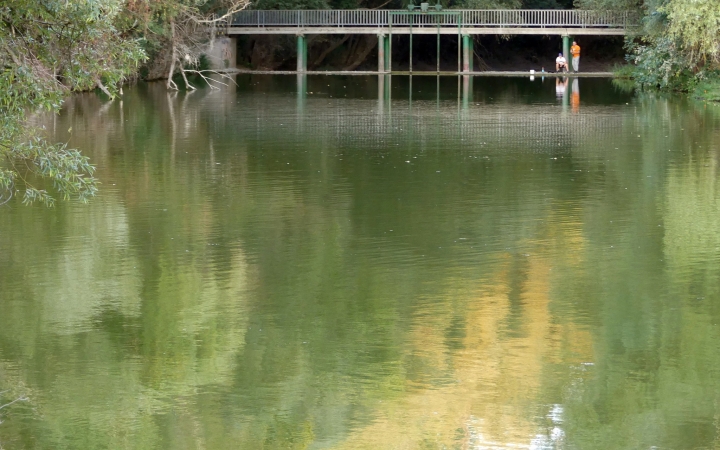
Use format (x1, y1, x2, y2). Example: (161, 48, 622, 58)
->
(228, 75, 627, 152)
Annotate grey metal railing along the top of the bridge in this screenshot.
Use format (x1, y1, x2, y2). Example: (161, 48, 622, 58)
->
(230, 9, 639, 28)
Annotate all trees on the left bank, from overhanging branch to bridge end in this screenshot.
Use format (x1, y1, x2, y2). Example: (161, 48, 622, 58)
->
(0, 0, 246, 205)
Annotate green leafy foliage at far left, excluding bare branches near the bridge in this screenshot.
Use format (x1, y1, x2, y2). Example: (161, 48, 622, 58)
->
(0, 0, 144, 205)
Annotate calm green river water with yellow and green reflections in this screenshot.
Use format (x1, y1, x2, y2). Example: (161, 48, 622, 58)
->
(0, 75, 720, 449)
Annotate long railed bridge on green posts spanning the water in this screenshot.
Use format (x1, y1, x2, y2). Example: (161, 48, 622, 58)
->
(224, 9, 640, 73)
